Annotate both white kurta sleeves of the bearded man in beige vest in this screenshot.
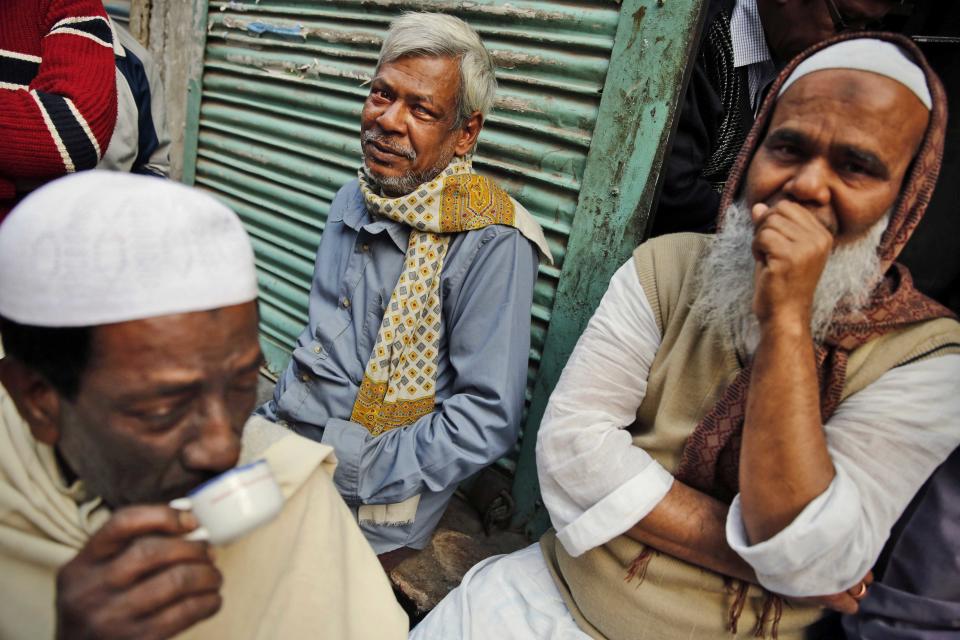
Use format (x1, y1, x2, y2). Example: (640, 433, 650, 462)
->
(537, 258, 960, 597)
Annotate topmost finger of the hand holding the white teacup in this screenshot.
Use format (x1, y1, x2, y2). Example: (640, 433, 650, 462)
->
(81, 505, 198, 561)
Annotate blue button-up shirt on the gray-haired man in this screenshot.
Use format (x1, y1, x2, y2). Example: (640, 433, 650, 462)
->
(257, 181, 537, 553)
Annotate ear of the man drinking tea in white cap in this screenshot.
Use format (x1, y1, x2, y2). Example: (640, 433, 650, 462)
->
(0, 356, 62, 446)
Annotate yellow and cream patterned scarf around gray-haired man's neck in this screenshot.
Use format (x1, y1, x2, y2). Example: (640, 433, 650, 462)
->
(350, 158, 552, 436)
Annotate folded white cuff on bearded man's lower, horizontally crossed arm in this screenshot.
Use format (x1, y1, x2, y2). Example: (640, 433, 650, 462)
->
(557, 460, 673, 558)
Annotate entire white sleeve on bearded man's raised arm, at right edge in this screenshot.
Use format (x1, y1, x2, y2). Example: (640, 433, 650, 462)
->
(726, 355, 960, 597)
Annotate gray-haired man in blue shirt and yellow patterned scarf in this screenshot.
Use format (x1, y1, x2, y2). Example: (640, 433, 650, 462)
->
(258, 13, 549, 569)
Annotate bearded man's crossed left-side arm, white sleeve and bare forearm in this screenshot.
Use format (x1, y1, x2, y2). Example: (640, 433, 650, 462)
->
(537, 259, 755, 580)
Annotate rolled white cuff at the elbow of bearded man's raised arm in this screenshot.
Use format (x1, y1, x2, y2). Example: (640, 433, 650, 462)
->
(726, 468, 869, 597)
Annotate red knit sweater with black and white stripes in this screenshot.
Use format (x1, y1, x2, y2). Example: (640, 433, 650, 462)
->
(0, 0, 117, 220)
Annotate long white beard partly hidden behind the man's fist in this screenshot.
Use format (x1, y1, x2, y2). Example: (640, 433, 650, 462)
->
(693, 201, 890, 357)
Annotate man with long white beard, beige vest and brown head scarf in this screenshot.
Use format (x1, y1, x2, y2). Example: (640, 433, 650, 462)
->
(413, 35, 960, 640)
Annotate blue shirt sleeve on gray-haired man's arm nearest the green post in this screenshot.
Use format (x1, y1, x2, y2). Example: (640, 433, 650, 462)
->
(322, 227, 537, 504)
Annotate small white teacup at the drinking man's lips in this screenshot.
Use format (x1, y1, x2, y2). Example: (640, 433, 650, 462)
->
(170, 460, 283, 544)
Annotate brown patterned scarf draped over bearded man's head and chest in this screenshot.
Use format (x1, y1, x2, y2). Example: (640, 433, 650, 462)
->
(676, 33, 952, 502)
